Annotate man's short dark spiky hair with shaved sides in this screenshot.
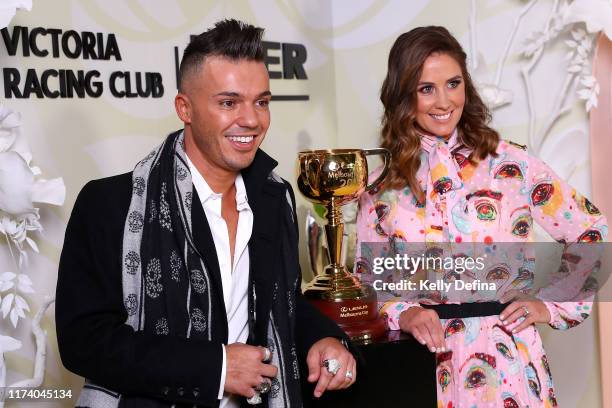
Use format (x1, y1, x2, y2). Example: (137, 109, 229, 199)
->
(179, 19, 264, 92)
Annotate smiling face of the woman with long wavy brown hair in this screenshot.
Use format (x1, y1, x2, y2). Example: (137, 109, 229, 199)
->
(416, 53, 465, 137)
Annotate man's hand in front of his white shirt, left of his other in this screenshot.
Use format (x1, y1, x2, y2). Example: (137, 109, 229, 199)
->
(224, 343, 278, 398)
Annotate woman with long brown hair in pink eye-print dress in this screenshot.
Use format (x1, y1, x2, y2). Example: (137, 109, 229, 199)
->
(356, 27, 607, 408)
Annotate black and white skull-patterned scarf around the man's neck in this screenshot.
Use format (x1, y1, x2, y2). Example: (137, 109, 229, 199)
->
(77, 132, 302, 408)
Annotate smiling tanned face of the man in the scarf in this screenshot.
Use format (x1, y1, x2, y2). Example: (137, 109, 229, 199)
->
(177, 56, 271, 173)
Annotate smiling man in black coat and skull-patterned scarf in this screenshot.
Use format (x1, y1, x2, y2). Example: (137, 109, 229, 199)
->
(56, 20, 356, 407)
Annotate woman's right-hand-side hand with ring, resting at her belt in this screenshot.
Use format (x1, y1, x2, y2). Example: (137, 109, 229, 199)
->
(499, 290, 550, 333)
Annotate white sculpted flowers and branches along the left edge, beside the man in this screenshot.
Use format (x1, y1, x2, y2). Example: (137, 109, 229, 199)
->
(0, 0, 66, 402)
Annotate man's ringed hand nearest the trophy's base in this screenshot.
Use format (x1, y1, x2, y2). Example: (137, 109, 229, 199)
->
(306, 337, 357, 398)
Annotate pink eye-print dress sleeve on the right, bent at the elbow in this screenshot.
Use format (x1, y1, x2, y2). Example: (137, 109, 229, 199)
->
(527, 151, 608, 329)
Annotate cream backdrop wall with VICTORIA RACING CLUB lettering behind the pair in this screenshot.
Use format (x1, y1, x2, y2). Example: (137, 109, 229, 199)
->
(0, 0, 612, 407)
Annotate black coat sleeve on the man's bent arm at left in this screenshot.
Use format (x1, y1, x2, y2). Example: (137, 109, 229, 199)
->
(56, 181, 223, 406)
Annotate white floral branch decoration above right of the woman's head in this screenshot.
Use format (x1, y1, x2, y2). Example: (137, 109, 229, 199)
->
(470, 0, 612, 153)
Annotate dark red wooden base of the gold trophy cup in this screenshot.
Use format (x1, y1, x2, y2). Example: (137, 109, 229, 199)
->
(304, 281, 388, 344)
